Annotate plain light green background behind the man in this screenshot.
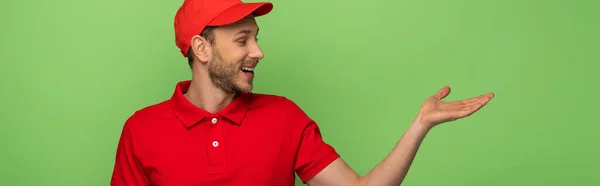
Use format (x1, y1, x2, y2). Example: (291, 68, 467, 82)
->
(0, 0, 600, 186)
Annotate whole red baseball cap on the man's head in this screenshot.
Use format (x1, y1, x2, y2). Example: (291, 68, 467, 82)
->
(175, 0, 273, 56)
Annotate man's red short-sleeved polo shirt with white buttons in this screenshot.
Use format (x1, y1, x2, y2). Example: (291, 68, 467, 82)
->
(110, 81, 339, 186)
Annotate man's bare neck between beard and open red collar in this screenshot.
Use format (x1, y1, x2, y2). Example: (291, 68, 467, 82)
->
(185, 72, 235, 113)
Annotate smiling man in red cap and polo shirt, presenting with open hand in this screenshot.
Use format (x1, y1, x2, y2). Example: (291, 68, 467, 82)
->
(111, 0, 493, 186)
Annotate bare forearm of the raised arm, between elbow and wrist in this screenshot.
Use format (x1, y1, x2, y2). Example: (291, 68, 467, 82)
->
(359, 123, 430, 186)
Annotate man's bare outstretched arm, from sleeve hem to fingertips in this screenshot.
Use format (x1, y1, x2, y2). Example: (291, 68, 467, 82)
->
(307, 87, 494, 186)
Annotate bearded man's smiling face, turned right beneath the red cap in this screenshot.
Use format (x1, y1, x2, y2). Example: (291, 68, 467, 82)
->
(198, 17, 263, 93)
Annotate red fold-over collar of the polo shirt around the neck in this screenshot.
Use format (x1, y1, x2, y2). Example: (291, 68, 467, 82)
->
(171, 80, 253, 128)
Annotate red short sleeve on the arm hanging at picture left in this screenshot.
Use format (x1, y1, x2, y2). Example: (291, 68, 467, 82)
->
(110, 116, 149, 186)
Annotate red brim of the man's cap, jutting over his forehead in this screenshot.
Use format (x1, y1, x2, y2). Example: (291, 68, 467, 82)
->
(208, 2, 273, 26)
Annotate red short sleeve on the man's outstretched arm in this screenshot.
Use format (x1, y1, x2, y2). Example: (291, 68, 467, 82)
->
(287, 100, 340, 183)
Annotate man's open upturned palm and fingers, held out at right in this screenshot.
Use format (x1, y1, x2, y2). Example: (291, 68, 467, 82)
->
(415, 86, 494, 128)
